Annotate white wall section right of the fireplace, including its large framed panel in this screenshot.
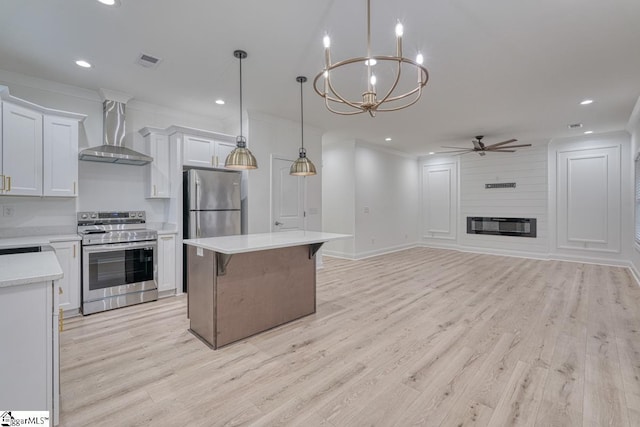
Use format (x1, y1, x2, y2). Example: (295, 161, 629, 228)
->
(548, 131, 633, 264)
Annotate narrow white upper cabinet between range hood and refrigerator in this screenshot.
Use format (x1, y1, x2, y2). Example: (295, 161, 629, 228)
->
(139, 128, 172, 199)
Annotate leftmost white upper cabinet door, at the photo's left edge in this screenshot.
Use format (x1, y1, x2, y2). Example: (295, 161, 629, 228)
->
(2, 103, 42, 196)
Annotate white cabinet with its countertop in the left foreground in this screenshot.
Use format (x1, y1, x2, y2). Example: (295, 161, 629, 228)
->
(0, 252, 62, 425)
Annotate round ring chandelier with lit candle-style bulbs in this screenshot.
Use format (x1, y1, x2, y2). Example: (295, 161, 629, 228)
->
(313, 0, 429, 117)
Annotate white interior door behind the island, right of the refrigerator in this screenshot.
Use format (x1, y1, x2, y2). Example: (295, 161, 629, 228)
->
(271, 158, 305, 231)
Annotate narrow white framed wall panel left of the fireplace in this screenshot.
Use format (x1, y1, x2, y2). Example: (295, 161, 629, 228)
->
(422, 163, 457, 239)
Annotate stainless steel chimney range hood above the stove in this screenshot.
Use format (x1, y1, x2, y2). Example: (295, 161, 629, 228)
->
(78, 99, 153, 166)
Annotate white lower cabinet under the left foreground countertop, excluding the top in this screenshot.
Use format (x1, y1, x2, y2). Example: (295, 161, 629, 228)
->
(0, 282, 59, 425)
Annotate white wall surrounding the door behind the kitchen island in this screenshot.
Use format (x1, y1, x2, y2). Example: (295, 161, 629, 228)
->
(247, 111, 323, 233)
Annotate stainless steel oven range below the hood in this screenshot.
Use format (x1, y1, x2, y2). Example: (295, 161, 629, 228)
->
(78, 211, 158, 314)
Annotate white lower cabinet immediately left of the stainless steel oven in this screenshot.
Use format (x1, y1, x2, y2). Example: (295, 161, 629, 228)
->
(51, 241, 80, 314)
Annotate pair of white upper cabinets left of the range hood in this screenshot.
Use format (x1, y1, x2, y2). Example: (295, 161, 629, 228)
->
(0, 86, 86, 197)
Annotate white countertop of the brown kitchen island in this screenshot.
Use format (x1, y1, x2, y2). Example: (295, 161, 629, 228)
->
(184, 231, 351, 255)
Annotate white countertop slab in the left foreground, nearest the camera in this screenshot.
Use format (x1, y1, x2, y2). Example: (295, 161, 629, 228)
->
(0, 251, 63, 288)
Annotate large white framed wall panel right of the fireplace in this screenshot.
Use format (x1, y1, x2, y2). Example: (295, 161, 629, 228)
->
(557, 146, 621, 252)
